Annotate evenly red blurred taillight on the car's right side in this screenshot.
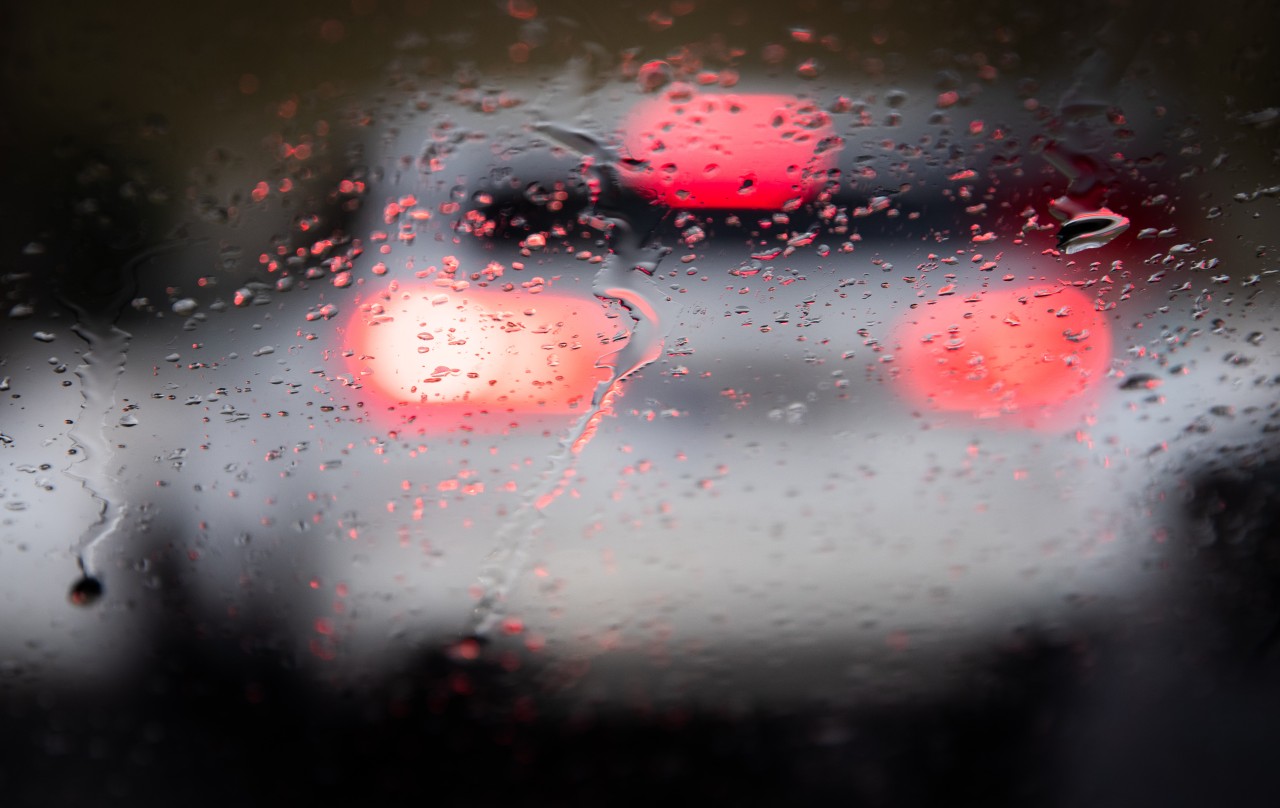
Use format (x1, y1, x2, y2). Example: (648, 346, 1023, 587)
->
(896, 287, 1111, 423)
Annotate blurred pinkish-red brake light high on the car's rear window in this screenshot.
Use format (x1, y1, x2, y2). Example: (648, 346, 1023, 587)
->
(621, 92, 840, 210)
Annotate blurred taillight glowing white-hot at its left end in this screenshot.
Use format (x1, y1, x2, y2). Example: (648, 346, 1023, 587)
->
(347, 284, 617, 414)
